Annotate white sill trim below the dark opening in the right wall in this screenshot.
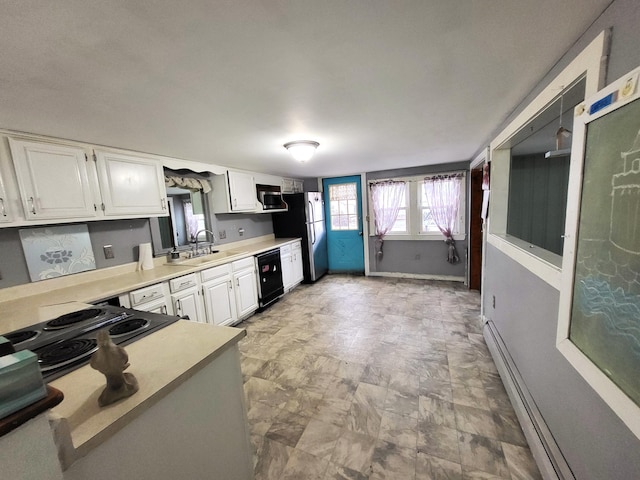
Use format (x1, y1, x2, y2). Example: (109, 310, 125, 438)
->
(487, 233, 562, 290)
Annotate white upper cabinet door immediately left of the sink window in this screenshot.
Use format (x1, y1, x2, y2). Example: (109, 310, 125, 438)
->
(95, 150, 168, 216)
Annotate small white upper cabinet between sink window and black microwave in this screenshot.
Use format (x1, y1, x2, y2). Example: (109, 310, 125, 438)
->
(213, 170, 258, 213)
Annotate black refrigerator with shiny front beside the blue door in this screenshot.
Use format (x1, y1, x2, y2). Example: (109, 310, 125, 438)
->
(272, 192, 329, 283)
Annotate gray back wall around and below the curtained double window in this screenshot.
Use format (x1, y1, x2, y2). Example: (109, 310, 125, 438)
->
(365, 162, 469, 277)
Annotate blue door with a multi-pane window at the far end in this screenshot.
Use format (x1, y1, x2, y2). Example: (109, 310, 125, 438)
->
(322, 175, 364, 273)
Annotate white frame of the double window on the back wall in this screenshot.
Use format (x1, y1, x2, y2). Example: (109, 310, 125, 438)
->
(367, 170, 467, 241)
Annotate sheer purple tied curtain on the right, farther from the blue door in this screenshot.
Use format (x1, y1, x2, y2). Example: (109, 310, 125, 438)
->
(424, 173, 464, 263)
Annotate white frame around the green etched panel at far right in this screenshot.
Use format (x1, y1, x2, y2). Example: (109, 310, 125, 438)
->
(556, 67, 640, 438)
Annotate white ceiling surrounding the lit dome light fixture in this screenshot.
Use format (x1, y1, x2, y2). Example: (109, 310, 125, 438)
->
(0, 0, 610, 177)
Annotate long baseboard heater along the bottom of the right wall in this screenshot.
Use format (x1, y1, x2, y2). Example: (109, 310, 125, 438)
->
(484, 321, 575, 480)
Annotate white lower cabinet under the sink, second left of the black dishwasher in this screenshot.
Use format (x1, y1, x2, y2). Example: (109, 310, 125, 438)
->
(200, 264, 238, 325)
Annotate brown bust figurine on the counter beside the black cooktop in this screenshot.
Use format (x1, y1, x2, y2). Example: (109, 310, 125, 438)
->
(91, 330, 138, 407)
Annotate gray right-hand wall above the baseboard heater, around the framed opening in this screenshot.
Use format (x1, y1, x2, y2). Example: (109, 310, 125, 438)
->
(483, 0, 640, 480)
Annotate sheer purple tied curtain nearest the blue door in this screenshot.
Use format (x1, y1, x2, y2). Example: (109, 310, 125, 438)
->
(369, 180, 406, 257)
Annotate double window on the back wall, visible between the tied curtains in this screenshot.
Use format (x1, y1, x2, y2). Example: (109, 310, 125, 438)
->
(369, 172, 465, 240)
